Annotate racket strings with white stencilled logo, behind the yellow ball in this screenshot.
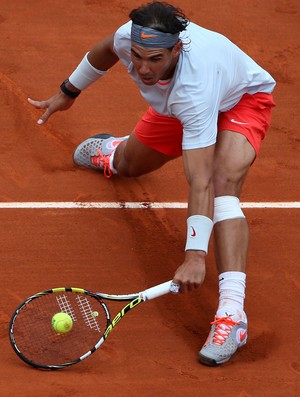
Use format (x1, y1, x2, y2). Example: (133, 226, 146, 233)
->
(13, 292, 108, 366)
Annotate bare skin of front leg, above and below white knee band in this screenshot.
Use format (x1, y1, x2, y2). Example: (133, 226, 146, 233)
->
(214, 131, 255, 273)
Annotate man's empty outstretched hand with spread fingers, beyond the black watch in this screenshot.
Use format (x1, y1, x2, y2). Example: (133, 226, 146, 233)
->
(28, 91, 75, 124)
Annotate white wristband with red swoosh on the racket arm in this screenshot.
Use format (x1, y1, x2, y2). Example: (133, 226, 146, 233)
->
(185, 215, 213, 253)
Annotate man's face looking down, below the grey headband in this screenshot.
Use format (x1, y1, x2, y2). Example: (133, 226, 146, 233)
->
(131, 42, 181, 85)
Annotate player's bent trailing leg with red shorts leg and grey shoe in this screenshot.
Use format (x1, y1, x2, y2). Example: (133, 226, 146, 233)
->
(73, 107, 182, 177)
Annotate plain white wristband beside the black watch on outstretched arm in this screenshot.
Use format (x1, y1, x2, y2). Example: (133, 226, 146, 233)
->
(69, 53, 107, 91)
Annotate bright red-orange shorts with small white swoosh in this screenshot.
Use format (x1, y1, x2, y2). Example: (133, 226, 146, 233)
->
(134, 92, 275, 156)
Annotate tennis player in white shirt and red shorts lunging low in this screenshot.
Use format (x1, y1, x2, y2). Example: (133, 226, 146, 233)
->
(29, 2, 275, 366)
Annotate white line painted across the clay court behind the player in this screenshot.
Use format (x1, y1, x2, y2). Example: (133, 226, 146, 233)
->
(0, 201, 300, 209)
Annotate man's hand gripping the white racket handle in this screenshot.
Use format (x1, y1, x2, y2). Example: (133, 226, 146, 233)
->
(173, 251, 205, 292)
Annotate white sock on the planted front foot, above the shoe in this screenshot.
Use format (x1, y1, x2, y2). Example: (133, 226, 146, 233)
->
(216, 272, 247, 321)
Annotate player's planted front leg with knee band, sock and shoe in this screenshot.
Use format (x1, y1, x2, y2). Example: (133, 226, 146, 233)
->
(199, 131, 255, 365)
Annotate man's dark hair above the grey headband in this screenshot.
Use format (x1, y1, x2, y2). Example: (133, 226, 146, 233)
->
(129, 1, 189, 34)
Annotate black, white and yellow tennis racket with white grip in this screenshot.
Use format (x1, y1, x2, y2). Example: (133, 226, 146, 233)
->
(9, 281, 179, 370)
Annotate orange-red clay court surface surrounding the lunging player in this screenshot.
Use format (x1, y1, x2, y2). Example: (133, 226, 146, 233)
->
(0, 0, 300, 397)
